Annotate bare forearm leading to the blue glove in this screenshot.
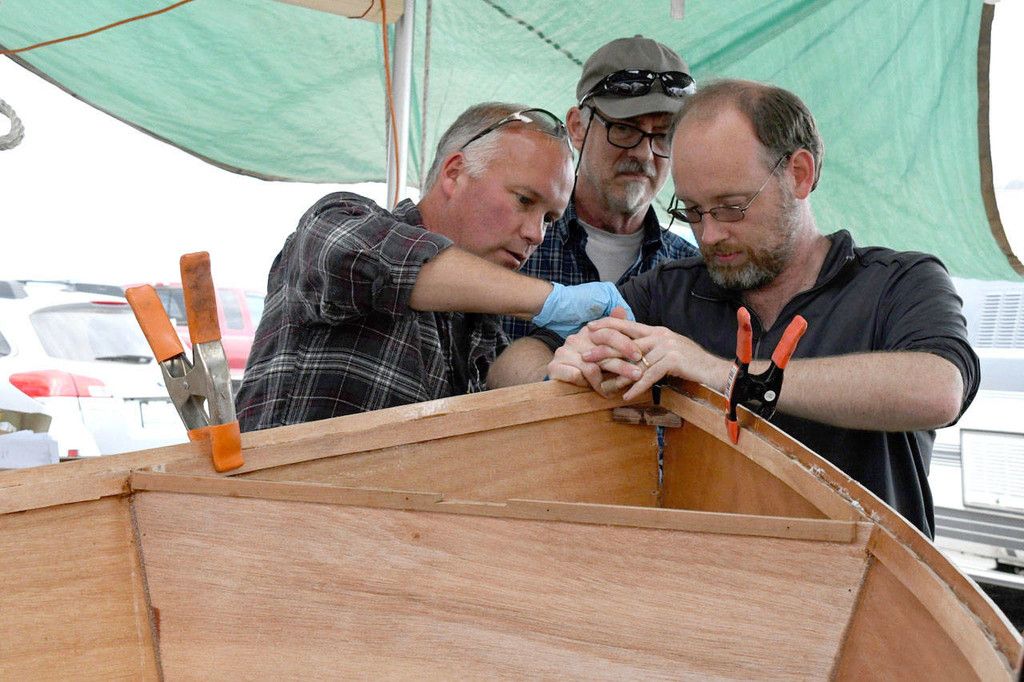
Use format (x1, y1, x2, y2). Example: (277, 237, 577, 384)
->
(410, 247, 552, 319)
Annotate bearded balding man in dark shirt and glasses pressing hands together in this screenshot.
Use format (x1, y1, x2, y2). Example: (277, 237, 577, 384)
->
(493, 81, 979, 537)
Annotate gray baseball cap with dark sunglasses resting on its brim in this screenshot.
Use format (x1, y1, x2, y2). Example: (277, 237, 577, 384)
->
(577, 35, 692, 119)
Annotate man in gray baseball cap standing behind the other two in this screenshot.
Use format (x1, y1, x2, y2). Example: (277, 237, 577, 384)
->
(504, 36, 697, 340)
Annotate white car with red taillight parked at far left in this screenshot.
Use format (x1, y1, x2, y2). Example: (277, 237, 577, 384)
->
(0, 282, 187, 459)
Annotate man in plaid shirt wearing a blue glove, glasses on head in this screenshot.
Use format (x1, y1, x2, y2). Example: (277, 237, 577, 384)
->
(237, 102, 622, 431)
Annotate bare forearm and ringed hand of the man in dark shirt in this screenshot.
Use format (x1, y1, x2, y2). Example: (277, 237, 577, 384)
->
(577, 319, 964, 431)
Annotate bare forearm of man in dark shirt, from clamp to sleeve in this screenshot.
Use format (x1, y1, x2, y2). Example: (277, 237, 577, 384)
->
(770, 351, 964, 431)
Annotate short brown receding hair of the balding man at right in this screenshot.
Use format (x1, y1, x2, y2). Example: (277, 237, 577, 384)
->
(671, 79, 825, 189)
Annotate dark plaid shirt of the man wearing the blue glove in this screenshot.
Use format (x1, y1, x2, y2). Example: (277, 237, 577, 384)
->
(238, 193, 507, 431)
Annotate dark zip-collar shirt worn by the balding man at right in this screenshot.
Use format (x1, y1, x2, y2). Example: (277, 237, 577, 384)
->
(536, 230, 980, 537)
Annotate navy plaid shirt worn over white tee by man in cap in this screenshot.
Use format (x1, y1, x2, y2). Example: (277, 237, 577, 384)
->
(502, 201, 700, 341)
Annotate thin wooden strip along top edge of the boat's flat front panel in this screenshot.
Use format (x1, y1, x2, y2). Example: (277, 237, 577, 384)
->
(130, 471, 870, 544)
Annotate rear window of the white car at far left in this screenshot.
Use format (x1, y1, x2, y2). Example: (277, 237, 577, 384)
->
(30, 303, 153, 363)
